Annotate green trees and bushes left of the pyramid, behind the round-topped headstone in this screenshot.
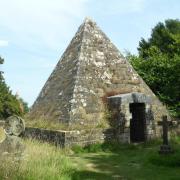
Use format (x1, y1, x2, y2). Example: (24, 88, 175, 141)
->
(0, 57, 28, 119)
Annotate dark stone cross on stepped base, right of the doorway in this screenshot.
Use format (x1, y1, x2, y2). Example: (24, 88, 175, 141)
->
(158, 116, 173, 154)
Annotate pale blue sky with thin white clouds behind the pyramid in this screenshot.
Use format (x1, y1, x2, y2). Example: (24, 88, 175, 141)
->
(0, 0, 180, 105)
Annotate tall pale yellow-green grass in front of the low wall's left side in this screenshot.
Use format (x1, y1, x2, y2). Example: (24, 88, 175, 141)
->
(0, 140, 74, 180)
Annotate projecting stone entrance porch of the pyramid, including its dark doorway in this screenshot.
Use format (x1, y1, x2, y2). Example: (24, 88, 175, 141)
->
(108, 92, 155, 143)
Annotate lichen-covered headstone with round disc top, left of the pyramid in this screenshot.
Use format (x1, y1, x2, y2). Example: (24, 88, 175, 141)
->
(0, 116, 25, 156)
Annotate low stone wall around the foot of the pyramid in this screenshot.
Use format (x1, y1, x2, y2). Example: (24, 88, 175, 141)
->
(22, 127, 115, 147)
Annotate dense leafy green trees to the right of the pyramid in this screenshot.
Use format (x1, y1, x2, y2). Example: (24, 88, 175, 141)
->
(127, 19, 180, 117)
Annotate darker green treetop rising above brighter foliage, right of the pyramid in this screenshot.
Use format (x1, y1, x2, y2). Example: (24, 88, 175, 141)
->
(138, 19, 180, 58)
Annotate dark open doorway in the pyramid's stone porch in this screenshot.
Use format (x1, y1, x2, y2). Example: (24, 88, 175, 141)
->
(130, 103, 146, 142)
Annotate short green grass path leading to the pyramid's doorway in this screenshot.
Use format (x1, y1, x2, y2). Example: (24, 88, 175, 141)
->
(70, 143, 180, 180)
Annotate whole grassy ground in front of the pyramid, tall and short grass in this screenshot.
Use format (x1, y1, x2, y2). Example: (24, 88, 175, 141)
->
(0, 139, 180, 180)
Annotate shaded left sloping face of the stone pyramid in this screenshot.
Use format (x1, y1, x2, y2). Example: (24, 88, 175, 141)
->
(30, 22, 83, 122)
